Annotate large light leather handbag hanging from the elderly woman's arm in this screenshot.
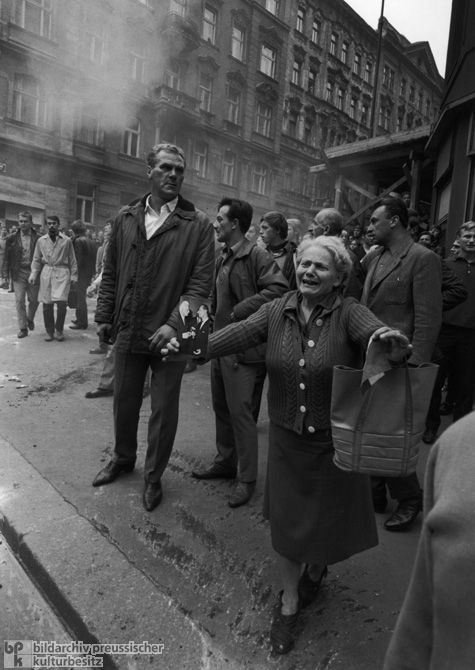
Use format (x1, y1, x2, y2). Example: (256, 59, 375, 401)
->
(331, 363, 439, 477)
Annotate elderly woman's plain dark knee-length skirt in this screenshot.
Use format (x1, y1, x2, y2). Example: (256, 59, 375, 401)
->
(264, 422, 378, 565)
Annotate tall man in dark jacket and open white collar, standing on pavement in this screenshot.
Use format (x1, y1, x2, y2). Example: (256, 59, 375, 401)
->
(93, 144, 214, 511)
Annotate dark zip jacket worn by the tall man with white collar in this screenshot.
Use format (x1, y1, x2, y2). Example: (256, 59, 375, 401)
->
(95, 194, 214, 355)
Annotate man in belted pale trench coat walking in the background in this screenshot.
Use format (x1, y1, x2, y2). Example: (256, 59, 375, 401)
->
(28, 215, 78, 342)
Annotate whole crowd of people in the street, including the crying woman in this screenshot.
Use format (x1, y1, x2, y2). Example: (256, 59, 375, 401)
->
(2, 144, 475, 668)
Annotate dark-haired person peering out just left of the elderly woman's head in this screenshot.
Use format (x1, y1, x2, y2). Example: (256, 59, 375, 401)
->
(259, 212, 297, 291)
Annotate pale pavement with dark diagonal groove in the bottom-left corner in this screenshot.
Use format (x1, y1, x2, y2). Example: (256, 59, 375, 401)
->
(0, 441, 232, 670)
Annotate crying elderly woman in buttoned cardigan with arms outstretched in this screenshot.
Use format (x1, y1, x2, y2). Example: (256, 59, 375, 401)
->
(162, 236, 410, 654)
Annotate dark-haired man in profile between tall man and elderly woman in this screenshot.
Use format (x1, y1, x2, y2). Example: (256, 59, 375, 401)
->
(192, 198, 288, 508)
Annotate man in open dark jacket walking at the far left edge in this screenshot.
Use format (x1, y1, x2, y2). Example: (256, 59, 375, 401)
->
(0, 211, 40, 338)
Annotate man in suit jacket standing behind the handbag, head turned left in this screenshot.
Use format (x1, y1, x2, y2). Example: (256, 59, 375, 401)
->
(361, 198, 442, 531)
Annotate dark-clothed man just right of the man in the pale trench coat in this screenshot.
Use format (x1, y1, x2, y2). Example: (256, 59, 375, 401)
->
(69, 221, 96, 330)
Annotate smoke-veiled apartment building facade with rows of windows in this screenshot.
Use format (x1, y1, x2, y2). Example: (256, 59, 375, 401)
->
(0, 0, 442, 228)
